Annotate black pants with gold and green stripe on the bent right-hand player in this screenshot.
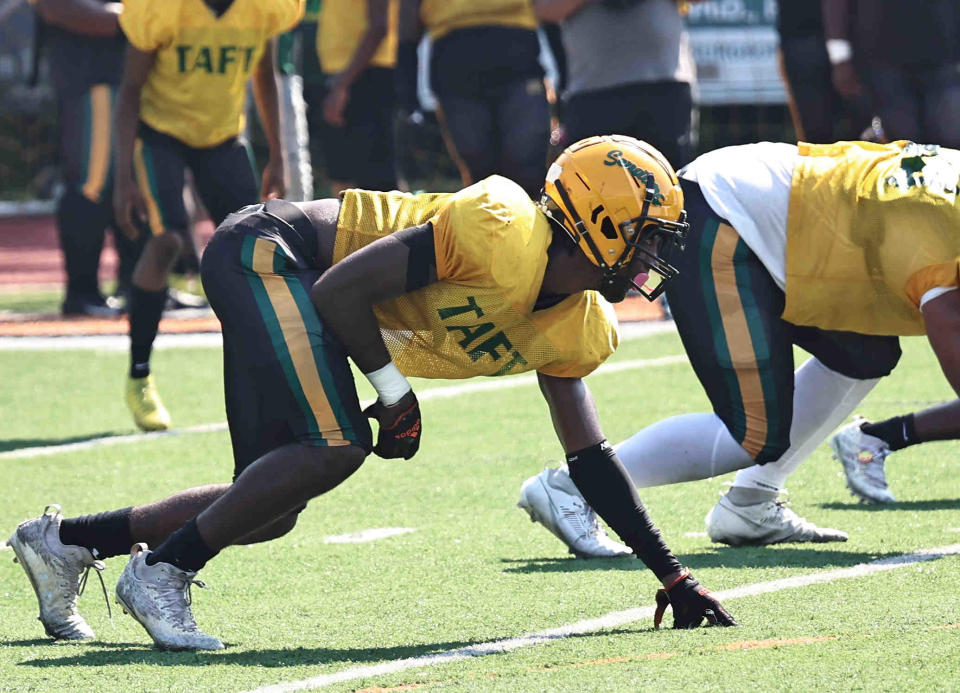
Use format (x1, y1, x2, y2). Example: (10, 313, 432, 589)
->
(666, 178, 900, 463)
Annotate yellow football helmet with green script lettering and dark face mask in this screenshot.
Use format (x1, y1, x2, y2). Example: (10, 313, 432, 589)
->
(540, 135, 690, 300)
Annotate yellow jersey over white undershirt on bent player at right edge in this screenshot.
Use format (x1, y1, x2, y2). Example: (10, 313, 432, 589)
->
(783, 141, 960, 335)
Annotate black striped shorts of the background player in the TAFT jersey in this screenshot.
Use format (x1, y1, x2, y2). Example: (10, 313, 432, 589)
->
(133, 122, 260, 236)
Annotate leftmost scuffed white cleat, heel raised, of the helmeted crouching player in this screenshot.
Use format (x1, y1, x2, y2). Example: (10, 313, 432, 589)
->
(7, 505, 109, 640)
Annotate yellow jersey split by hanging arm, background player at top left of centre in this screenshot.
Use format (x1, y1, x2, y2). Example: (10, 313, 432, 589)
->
(317, 0, 400, 74)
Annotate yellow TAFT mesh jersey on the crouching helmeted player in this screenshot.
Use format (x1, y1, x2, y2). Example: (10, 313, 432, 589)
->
(333, 176, 619, 378)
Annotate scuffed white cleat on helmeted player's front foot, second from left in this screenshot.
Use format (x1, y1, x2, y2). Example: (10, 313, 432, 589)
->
(117, 543, 223, 650)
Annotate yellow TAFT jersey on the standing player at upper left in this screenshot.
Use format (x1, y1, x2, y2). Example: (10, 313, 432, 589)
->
(120, 0, 303, 147)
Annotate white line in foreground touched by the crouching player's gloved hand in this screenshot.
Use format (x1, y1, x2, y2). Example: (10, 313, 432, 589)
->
(248, 544, 960, 693)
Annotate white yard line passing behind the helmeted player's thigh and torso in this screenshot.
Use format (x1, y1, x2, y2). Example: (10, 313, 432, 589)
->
(0, 355, 687, 460)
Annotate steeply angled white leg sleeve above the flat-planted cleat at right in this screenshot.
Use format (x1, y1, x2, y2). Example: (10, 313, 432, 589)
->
(733, 358, 880, 492)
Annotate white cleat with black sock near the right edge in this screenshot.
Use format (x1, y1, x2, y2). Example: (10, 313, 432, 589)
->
(830, 416, 897, 503)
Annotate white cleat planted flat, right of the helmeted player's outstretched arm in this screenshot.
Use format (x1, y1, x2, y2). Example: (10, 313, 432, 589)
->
(706, 496, 847, 546)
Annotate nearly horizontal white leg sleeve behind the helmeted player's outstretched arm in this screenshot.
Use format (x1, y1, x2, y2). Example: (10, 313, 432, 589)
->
(615, 414, 753, 488)
